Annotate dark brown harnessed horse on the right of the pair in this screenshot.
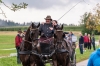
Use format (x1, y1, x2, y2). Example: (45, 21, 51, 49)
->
(54, 25, 71, 66)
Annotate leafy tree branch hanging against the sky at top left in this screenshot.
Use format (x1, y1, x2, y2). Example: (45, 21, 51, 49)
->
(0, 0, 28, 17)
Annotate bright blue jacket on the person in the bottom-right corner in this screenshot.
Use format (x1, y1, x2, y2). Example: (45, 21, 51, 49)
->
(87, 48, 100, 66)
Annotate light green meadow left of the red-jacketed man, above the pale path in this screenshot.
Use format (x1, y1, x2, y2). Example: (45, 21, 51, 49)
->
(0, 35, 16, 56)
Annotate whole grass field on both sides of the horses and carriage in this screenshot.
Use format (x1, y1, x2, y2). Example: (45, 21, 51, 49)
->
(0, 31, 99, 66)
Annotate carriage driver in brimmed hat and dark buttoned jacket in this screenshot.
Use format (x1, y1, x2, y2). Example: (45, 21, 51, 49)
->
(39, 15, 54, 43)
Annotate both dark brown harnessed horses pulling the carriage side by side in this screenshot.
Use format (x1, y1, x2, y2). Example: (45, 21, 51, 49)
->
(19, 23, 71, 66)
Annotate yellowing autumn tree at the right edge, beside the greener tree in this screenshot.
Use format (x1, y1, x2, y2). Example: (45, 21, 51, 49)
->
(86, 4, 100, 32)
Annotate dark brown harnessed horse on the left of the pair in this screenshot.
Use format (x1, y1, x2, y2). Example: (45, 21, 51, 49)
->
(20, 23, 43, 66)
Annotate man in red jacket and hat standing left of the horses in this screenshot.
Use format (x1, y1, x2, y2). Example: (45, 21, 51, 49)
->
(15, 30, 22, 64)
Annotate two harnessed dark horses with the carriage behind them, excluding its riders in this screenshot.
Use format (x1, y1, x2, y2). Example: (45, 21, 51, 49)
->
(19, 23, 76, 66)
